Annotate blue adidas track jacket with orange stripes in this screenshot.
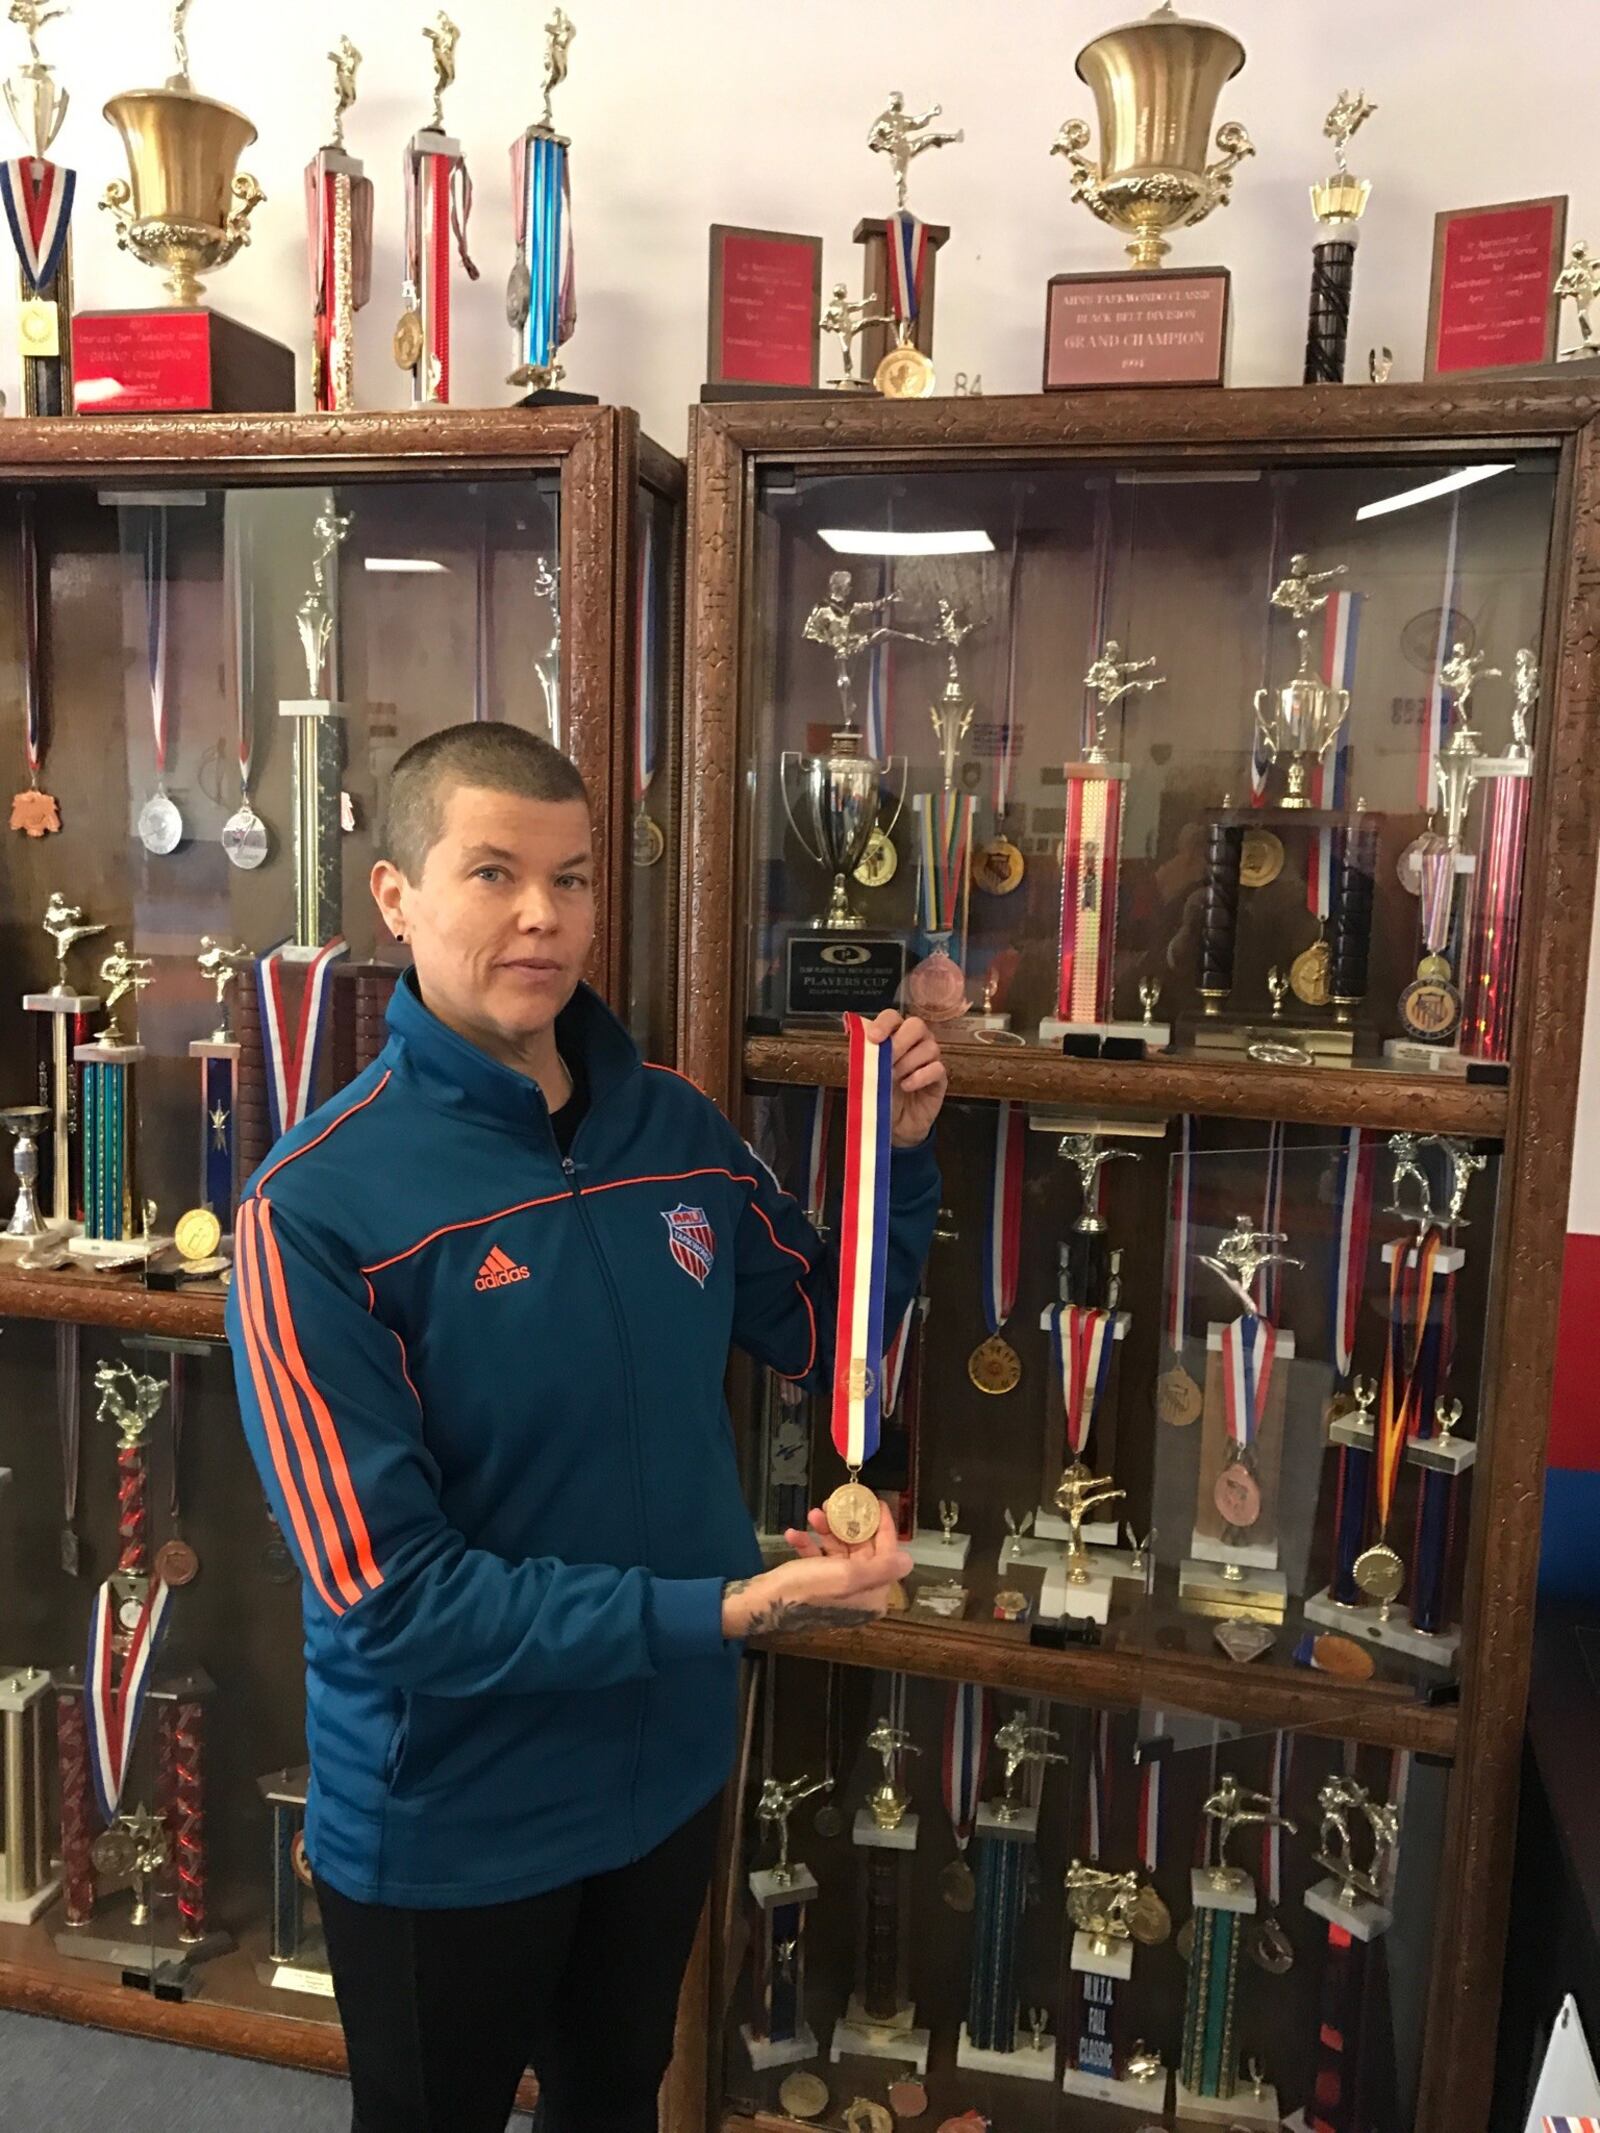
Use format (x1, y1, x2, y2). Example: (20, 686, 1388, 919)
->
(228, 977, 939, 1907)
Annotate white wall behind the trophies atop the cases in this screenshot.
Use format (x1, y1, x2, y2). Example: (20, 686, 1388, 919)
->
(21, 0, 1600, 448)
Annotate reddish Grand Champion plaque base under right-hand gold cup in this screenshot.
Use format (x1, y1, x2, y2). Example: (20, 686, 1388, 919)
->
(1045, 267, 1229, 392)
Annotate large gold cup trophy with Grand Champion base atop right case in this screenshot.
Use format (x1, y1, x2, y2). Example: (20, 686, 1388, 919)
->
(1045, 0, 1254, 386)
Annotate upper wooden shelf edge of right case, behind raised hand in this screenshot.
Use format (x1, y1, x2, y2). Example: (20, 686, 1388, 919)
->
(745, 1035, 1506, 1141)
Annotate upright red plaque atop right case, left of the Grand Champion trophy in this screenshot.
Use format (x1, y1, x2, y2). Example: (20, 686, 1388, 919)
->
(706, 222, 821, 390)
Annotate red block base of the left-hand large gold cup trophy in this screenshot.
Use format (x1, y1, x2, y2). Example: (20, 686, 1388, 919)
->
(73, 305, 294, 414)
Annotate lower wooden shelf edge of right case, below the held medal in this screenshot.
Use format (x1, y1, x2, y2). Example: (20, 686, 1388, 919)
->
(755, 1619, 1457, 1755)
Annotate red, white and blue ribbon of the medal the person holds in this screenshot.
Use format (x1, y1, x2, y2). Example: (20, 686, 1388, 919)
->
(832, 1015, 894, 1474)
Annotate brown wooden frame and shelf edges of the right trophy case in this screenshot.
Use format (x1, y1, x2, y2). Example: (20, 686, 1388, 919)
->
(668, 375, 1600, 2133)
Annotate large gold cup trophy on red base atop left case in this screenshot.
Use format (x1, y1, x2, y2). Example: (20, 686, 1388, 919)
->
(75, 0, 294, 414)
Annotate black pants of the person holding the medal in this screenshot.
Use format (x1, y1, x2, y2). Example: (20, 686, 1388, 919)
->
(316, 1800, 721, 2133)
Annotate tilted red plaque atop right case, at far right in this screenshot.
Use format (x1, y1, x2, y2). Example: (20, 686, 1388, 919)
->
(1425, 194, 1566, 378)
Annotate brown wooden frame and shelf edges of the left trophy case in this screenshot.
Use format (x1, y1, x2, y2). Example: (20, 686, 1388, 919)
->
(0, 407, 685, 2103)
